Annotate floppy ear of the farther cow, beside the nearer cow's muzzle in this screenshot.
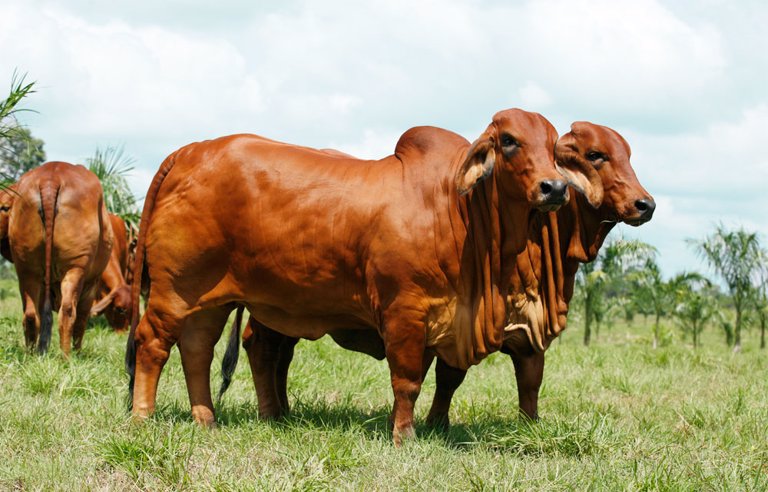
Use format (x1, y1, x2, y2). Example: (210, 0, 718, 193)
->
(555, 132, 604, 208)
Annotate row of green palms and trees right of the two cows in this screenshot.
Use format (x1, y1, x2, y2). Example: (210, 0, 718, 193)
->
(575, 230, 768, 352)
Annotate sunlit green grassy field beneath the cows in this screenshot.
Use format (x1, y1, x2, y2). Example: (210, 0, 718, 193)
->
(0, 281, 768, 490)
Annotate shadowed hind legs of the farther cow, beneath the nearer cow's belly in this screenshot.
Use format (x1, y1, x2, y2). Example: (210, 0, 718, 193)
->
(243, 317, 298, 419)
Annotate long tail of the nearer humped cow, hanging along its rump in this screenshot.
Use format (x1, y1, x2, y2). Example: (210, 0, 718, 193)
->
(125, 152, 176, 409)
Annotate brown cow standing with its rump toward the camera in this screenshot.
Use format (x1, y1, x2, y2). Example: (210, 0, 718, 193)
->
(8, 162, 113, 356)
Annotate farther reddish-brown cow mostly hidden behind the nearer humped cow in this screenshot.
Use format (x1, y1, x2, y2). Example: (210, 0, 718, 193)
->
(226, 122, 656, 427)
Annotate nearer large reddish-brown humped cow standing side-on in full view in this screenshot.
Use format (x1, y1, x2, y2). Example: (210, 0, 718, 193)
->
(126, 110, 600, 443)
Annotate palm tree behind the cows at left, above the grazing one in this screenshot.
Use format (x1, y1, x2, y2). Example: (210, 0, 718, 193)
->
(86, 147, 141, 226)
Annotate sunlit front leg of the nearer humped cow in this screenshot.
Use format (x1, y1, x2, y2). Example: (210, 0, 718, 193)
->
(384, 320, 426, 446)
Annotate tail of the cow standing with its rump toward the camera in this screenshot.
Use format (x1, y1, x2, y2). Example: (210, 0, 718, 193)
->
(37, 182, 61, 354)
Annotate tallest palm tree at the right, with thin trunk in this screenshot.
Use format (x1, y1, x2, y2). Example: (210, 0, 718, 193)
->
(688, 224, 765, 352)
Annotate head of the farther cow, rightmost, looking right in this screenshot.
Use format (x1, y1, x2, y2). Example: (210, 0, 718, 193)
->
(555, 121, 656, 226)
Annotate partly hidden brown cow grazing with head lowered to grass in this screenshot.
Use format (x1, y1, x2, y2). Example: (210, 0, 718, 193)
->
(91, 213, 131, 331)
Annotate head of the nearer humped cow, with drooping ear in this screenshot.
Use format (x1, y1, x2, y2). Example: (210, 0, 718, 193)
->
(456, 109, 568, 211)
